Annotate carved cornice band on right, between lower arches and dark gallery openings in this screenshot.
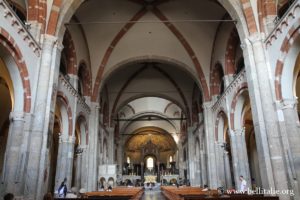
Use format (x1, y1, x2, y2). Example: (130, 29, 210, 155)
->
(212, 69, 246, 111)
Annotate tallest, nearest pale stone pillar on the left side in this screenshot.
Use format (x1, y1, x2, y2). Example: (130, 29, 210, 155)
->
(24, 35, 61, 199)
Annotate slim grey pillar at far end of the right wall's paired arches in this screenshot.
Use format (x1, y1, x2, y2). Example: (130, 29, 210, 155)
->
(203, 102, 218, 188)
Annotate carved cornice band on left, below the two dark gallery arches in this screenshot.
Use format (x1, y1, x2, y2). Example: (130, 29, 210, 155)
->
(59, 74, 91, 114)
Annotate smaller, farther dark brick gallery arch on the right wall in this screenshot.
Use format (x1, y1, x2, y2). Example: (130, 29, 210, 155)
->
(210, 62, 225, 96)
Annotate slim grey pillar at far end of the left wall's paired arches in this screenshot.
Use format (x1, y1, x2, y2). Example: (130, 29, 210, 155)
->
(85, 102, 100, 191)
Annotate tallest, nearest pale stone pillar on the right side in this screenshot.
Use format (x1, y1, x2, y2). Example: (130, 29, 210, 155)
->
(242, 33, 290, 200)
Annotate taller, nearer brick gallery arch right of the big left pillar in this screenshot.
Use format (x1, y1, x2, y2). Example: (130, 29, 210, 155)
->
(63, 30, 78, 75)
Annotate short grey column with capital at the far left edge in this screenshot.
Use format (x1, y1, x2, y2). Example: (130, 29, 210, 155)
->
(1, 112, 25, 196)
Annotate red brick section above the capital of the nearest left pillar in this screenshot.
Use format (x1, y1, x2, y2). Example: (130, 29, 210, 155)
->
(25, 0, 47, 33)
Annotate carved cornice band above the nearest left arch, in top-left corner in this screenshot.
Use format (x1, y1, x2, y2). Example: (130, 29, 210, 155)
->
(0, 0, 41, 57)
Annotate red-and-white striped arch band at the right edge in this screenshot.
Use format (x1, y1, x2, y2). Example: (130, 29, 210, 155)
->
(275, 19, 300, 101)
